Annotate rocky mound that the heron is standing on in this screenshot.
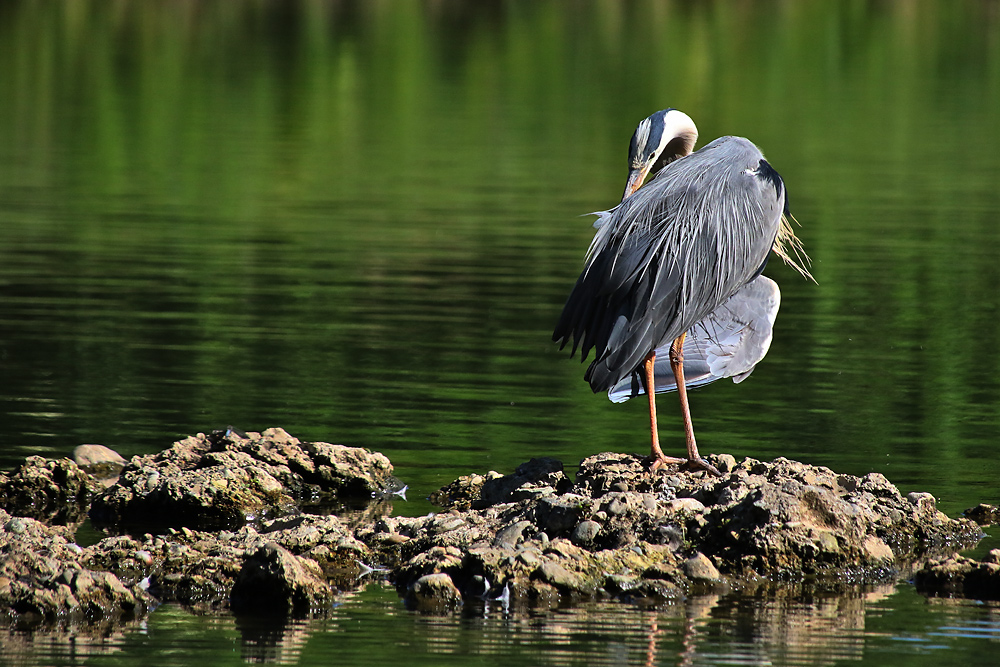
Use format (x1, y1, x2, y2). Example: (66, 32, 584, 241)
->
(366, 453, 980, 606)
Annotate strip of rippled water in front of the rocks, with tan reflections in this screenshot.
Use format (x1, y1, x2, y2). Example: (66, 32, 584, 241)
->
(0, 586, 1000, 666)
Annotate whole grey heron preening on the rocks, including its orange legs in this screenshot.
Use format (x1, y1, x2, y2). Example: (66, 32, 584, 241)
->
(552, 109, 811, 475)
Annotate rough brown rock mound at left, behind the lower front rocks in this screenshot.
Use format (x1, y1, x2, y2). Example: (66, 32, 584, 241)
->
(90, 428, 394, 531)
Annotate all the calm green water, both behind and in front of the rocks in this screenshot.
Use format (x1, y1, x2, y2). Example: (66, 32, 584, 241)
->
(0, 0, 1000, 665)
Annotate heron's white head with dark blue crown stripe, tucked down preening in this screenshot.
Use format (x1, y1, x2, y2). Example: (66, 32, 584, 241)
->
(622, 109, 698, 200)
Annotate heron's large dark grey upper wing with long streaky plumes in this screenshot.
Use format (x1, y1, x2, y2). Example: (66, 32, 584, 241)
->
(553, 137, 784, 392)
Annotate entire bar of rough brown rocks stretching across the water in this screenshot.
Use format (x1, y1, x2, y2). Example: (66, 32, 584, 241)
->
(0, 429, 988, 623)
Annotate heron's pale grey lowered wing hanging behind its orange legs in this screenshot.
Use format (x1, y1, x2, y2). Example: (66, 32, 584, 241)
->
(608, 276, 781, 403)
